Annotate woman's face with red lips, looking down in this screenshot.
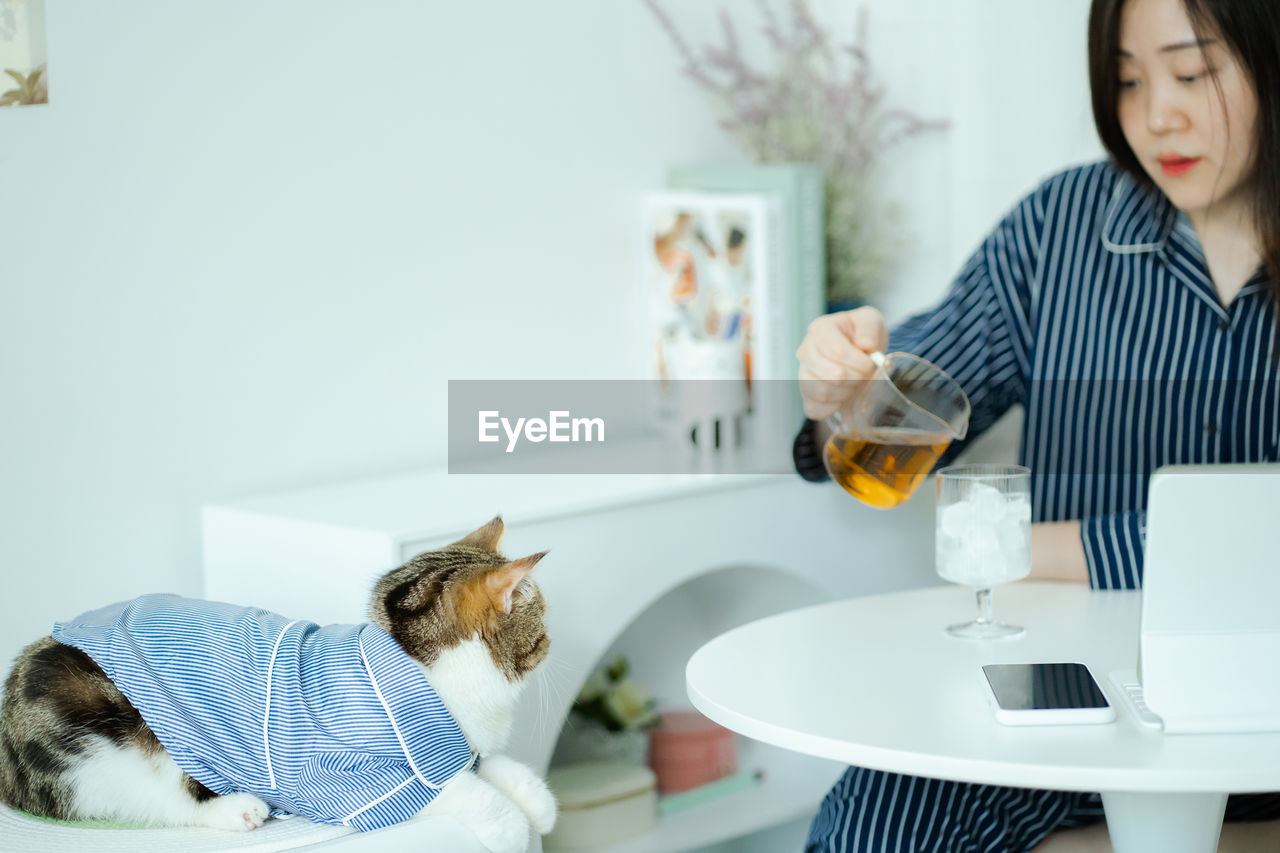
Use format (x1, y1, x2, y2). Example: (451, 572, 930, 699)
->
(1116, 0, 1258, 222)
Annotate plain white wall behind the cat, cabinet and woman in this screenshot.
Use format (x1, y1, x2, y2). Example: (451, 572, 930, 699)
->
(0, 0, 1092, 670)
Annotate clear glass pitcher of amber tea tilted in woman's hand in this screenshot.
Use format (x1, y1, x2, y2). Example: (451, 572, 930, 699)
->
(822, 352, 969, 510)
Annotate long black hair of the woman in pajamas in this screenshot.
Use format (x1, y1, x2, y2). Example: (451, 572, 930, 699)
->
(1089, 0, 1280, 325)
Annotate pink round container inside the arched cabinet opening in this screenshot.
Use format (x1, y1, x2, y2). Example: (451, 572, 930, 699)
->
(649, 711, 737, 794)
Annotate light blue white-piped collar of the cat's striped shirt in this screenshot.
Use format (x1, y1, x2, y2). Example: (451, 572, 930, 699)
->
(360, 624, 475, 789)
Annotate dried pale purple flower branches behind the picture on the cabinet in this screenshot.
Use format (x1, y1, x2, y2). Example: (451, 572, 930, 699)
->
(644, 0, 947, 300)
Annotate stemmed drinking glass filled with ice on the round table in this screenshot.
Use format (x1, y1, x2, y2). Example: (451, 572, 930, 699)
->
(936, 465, 1032, 639)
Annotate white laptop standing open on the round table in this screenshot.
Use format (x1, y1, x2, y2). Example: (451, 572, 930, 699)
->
(1111, 464, 1280, 734)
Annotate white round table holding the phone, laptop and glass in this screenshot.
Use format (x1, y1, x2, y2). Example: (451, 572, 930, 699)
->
(686, 581, 1280, 853)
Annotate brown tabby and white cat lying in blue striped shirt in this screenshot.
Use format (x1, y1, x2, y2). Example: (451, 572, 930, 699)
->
(0, 516, 557, 853)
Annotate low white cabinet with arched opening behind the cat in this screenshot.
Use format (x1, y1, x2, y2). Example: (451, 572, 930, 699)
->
(204, 471, 937, 853)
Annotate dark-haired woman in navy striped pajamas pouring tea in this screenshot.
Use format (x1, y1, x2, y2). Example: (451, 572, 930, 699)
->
(795, 0, 1280, 853)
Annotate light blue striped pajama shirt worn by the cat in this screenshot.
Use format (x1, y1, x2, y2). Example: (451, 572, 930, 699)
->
(52, 596, 474, 831)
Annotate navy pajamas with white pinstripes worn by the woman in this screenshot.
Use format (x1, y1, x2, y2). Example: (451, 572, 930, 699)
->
(796, 163, 1280, 853)
